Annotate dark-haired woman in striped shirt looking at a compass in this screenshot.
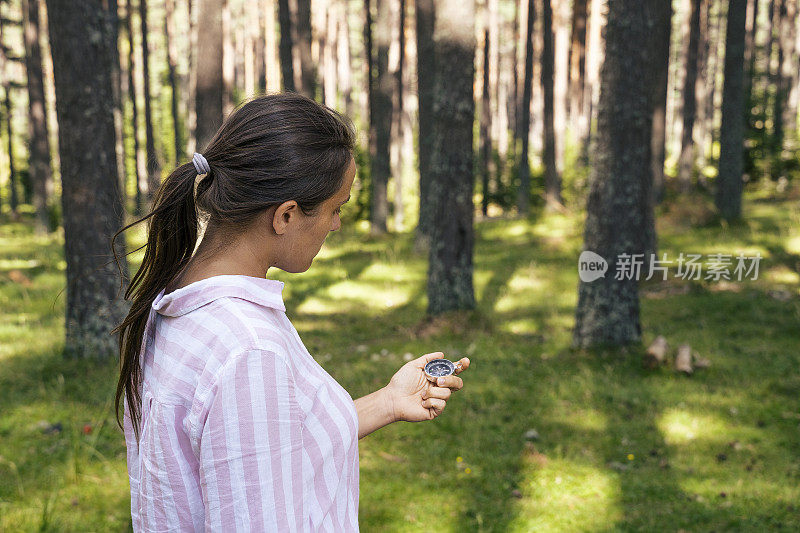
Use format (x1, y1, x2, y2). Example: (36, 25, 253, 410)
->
(112, 93, 476, 532)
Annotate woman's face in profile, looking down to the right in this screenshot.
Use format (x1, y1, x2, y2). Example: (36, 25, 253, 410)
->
(275, 158, 356, 272)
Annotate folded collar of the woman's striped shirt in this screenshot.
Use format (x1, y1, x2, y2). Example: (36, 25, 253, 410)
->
(152, 274, 286, 316)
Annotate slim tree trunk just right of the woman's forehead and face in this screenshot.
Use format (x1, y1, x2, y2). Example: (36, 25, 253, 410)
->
(370, 0, 394, 234)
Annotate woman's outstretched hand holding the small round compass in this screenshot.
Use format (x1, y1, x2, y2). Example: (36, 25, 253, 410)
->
(385, 352, 469, 422)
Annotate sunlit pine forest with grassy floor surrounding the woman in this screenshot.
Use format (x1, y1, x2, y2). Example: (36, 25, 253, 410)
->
(0, 0, 800, 531)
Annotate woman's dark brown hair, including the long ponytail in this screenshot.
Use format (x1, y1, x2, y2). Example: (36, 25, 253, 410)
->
(111, 92, 355, 442)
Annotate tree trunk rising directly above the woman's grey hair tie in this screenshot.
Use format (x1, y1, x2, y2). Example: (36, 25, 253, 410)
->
(195, 0, 224, 151)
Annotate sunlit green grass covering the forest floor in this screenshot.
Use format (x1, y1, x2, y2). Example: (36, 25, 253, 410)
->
(0, 186, 800, 532)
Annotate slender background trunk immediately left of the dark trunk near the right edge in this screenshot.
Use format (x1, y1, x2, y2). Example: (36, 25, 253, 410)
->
(678, 0, 702, 192)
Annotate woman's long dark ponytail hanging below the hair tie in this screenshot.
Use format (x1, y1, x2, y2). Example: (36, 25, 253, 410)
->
(111, 163, 202, 442)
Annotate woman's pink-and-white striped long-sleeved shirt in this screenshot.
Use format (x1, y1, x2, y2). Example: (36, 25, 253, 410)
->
(124, 275, 359, 532)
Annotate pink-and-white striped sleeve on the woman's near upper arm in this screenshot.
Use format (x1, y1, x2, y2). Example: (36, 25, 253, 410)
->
(199, 349, 310, 531)
